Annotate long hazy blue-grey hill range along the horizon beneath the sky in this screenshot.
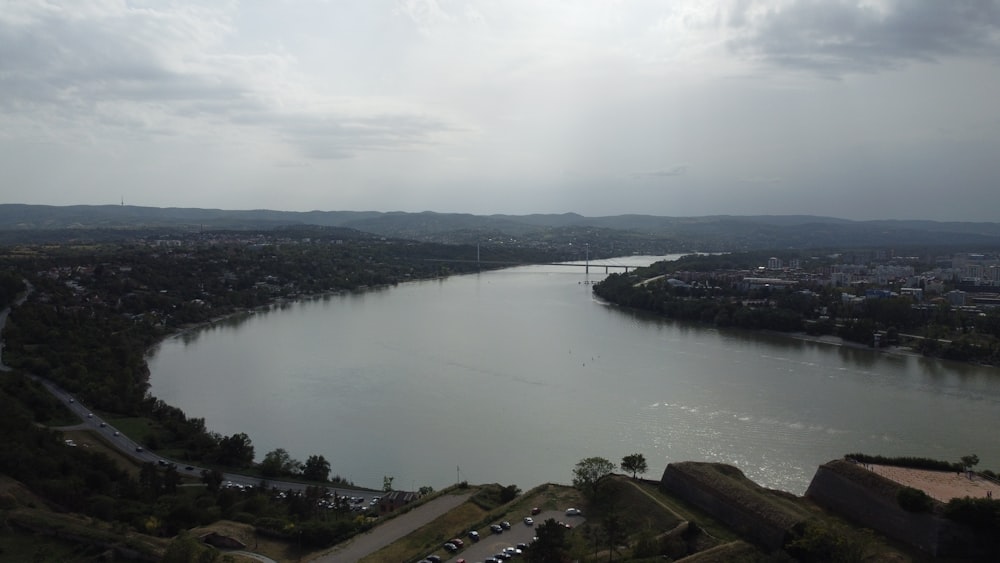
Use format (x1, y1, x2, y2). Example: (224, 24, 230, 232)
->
(0, 204, 1000, 252)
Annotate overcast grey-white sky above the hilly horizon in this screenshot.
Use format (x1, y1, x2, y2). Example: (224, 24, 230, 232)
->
(0, 0, 1000, 221)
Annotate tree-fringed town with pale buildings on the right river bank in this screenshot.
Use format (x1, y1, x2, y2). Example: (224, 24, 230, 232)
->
(594, 249, 1000, 365)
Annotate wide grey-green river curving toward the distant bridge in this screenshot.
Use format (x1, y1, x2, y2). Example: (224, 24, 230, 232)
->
(150, 257, 1000, 494)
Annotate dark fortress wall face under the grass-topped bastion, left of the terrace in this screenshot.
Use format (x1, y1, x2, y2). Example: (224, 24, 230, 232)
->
(660, 462, 793, 550)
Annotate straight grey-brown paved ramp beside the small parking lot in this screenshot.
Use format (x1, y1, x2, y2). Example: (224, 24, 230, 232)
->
(311, 494, 470, 563)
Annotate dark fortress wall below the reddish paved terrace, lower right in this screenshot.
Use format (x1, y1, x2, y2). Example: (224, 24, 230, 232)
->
(806, 460, 980, 557)
